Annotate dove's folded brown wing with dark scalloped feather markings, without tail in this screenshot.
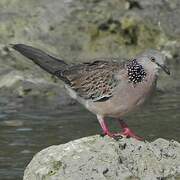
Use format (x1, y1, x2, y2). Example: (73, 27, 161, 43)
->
(55, 60, 124, 101)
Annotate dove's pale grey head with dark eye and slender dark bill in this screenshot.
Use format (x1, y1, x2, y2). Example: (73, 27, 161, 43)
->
(136, 50, 170, 75)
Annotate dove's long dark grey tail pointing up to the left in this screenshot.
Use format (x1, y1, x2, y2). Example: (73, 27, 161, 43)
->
(11, 44, 67, 74)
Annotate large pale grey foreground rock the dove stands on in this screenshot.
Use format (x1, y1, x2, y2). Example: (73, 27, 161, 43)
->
(24, 135, 180, 180)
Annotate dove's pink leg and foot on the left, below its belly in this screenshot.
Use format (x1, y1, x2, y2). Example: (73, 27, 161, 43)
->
(97, 116, 122, 137)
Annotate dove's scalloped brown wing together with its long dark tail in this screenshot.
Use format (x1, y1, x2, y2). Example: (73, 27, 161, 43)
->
(13, 44, 124, 101)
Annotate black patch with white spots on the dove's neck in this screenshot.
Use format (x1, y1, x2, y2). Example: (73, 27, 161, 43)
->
(127, 59, 146, 84)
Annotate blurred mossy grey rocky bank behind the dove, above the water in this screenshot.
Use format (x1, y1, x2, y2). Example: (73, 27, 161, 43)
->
(0, 0, 180, 104)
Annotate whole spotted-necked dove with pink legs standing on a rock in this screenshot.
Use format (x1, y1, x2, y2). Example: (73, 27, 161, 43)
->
(11, 44, 170, 140)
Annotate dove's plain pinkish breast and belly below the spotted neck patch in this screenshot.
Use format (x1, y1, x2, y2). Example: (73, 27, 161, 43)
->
(88, 72, 156, 117)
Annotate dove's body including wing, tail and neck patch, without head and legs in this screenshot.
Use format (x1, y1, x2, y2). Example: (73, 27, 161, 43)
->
(13, 44, 156, 117)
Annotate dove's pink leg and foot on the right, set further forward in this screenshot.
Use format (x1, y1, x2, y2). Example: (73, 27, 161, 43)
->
(119, 119, 143, 141)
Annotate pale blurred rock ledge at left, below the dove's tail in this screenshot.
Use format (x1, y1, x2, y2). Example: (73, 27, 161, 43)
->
(0, 71, 73, 105)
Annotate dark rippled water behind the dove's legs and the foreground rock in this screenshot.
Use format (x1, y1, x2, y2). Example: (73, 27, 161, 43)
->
(0, 62, 180, 180)
